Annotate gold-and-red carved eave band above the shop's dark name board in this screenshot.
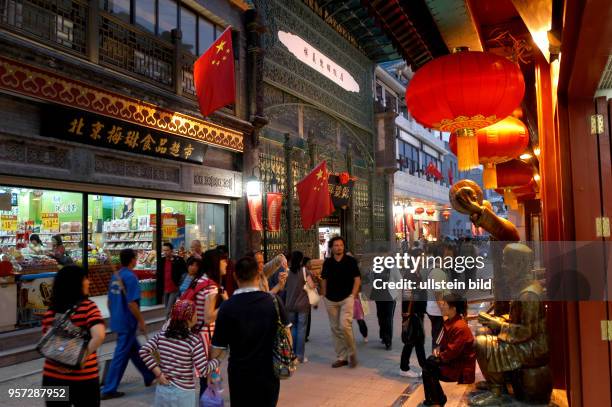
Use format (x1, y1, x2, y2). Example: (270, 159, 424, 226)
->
(0, 57, 244, 152)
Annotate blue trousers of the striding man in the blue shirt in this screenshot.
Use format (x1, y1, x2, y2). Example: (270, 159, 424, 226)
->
(102, 331, 155, 394)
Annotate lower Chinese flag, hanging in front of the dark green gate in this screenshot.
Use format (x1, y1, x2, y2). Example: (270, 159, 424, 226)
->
(297, 161, 334, 229)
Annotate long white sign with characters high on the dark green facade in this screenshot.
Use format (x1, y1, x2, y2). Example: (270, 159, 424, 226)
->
(278, 31, 359, 93)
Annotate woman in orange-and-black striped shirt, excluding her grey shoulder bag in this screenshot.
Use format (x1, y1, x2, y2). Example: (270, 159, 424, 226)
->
(42, 265, 106, 407)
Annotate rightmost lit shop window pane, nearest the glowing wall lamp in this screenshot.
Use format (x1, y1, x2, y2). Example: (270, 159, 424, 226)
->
(162, 201, 227, 255)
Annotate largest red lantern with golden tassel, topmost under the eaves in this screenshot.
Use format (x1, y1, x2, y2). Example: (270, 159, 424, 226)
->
(406, 51, 525, 171)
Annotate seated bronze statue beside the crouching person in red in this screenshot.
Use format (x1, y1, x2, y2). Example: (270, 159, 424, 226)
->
(470, 243, 552, 406)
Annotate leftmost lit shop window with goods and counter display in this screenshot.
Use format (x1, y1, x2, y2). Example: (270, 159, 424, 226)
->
(0, 186, 83, 327)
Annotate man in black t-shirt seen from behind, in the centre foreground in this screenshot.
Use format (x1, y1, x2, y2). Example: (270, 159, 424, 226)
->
(210, 257, 291, 407)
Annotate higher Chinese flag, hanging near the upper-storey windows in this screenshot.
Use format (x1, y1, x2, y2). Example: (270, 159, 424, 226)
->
(193, 26, 236, 117)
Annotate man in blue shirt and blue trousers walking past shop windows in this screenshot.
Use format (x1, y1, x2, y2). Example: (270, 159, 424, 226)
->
(101, 249, 155, 400)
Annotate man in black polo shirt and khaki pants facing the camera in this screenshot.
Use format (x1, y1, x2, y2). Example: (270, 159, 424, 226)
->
(321, 236, 361, 368)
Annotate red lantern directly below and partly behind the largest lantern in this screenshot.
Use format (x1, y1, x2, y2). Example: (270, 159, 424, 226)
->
(449, 116, 529, 189)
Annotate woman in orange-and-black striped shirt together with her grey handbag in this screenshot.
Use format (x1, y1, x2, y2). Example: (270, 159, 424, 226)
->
(38, 265, 106, 407)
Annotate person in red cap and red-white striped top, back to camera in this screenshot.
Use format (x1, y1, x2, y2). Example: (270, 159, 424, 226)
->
(140, 300, 219, 407)
